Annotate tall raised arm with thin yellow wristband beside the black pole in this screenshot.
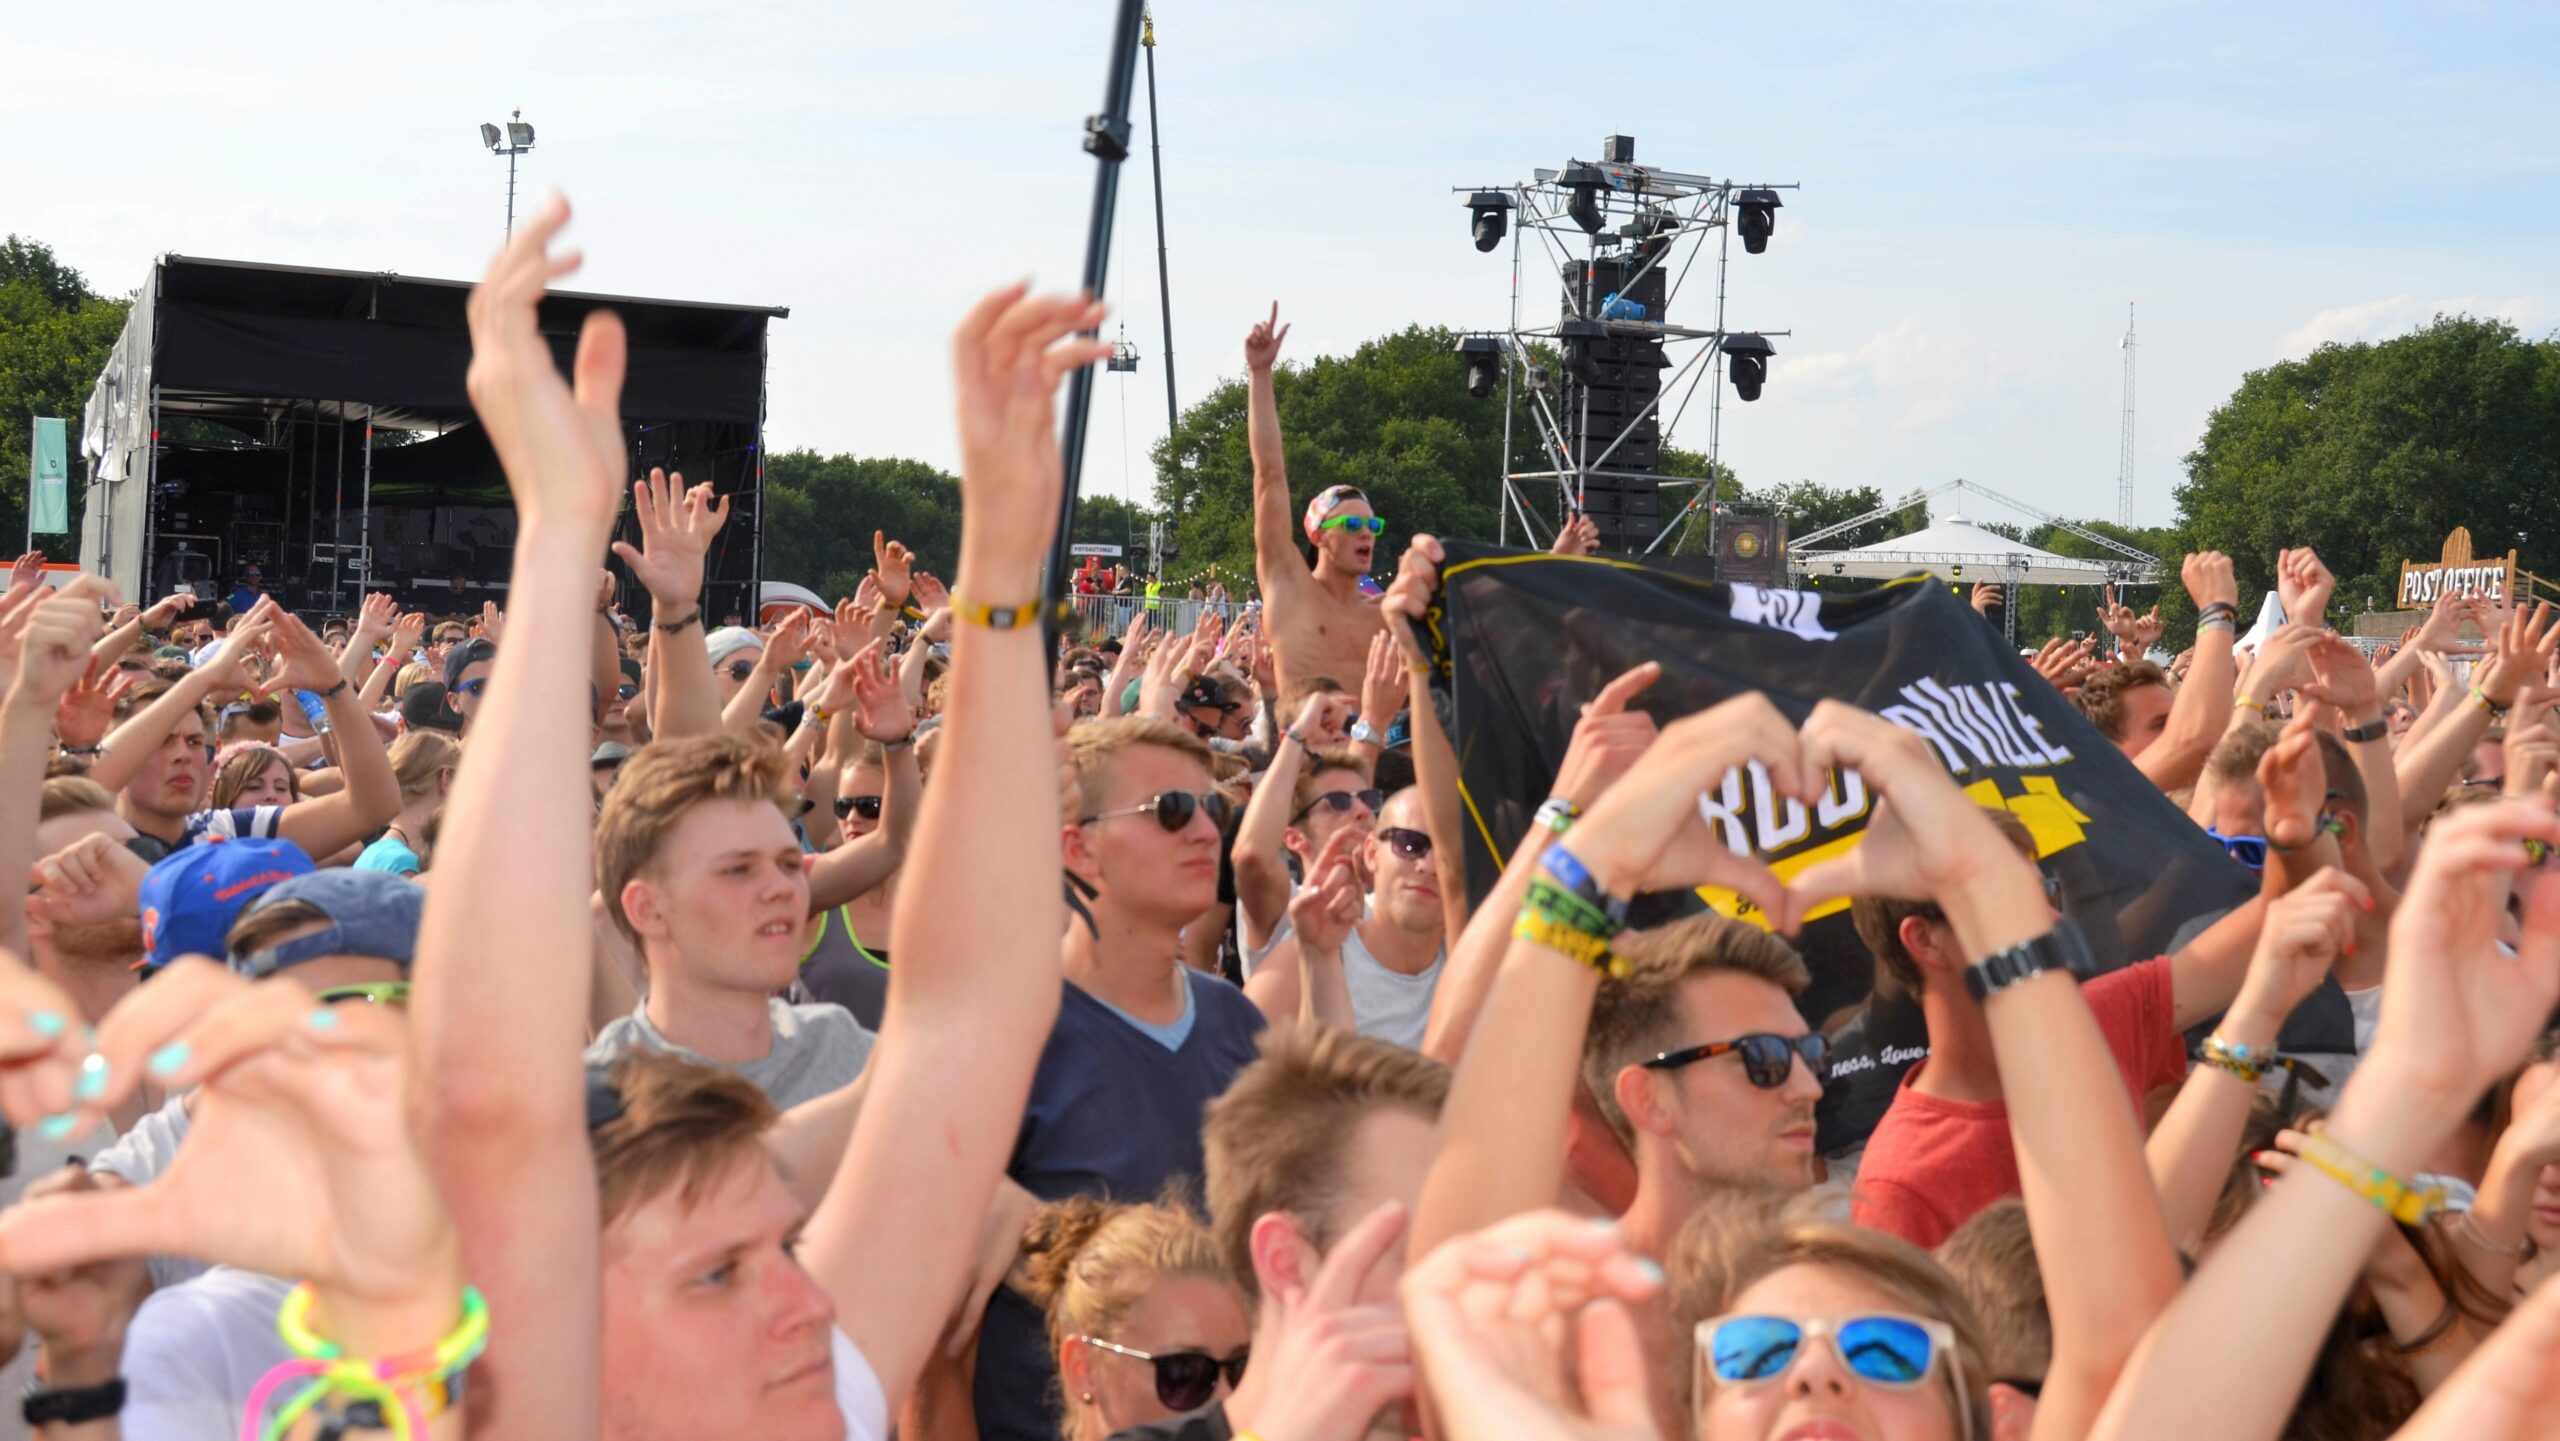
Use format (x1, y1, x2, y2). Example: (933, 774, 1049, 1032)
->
(801, 287, 1111, 1410)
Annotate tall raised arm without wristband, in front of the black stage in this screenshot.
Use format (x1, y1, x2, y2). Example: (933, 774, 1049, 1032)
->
(410, 197, 634, 1438)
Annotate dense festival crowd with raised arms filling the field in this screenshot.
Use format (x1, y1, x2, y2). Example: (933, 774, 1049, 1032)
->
(0, 202, 2560, 1441)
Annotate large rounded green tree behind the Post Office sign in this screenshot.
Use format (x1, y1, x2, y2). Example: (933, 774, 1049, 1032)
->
(2161, 315, 2560, 625)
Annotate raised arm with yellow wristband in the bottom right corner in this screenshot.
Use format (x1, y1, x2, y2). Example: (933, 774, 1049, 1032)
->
(2094, 801, 2560, 1441)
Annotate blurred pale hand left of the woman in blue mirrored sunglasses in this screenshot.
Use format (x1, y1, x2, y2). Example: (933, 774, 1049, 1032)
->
(1400, 1211, 1661, 1441)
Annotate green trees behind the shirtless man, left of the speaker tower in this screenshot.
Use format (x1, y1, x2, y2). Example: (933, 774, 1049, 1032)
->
(1155, 325, 1536, 584)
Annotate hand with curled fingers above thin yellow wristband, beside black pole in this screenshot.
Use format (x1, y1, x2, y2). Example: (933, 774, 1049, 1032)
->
(952, 284, 1111, 578)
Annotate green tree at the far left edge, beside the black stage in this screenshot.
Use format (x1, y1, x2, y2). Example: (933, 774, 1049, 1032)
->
(0, 235, 125, 561)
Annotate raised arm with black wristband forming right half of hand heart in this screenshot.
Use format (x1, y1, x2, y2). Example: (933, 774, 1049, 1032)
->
(1787, 701, 2179, 1438)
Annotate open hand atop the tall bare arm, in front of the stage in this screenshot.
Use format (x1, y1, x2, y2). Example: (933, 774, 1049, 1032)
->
(463, 195, 627, 525)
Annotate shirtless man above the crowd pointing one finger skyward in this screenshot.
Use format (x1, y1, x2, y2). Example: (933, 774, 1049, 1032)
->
(1244, 302, 1385, 691)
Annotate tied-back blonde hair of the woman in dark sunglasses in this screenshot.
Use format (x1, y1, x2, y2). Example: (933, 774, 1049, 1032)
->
(1014, 1195, 1234, 1433)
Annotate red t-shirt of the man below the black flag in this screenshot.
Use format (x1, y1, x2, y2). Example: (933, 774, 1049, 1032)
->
(1848, 957, 2186, 1249)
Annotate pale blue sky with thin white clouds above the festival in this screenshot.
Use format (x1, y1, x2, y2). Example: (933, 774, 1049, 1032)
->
(0, 0, 2560, 525)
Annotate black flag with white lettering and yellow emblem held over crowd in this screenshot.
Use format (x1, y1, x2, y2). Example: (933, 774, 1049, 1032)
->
(1428, 543, 2255, 1152)
